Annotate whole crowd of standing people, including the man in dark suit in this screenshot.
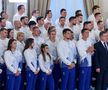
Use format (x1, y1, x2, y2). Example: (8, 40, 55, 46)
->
(0, 5, 108, 90)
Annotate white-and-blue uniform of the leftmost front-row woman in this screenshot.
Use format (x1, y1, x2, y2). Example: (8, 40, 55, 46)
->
(4, 50, 22, 90)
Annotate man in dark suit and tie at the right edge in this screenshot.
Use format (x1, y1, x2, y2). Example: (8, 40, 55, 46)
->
(94, 31, 108, 90)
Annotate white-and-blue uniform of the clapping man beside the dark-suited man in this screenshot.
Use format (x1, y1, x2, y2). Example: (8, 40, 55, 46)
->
(77, 39, 92, 90)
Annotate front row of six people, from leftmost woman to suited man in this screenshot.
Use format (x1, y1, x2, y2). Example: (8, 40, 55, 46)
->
(1, 28, 108, 90)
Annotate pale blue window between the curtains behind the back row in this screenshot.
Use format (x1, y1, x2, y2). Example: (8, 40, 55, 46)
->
(50, 0, 87, 22)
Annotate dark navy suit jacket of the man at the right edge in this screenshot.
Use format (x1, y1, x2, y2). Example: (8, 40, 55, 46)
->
(94, 41, 108, 70)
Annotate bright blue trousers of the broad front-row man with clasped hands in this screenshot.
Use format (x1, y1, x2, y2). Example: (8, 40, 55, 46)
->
(61, 67, 76, 90)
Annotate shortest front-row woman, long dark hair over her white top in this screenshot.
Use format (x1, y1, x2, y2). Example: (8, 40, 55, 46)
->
(39, 44, 54, 90)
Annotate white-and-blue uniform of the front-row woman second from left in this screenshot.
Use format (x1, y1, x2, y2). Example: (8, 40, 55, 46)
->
(24, 48, 40, 90)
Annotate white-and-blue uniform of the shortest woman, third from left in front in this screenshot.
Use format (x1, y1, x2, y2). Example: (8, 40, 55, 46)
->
(39, 54, 54, 90)
